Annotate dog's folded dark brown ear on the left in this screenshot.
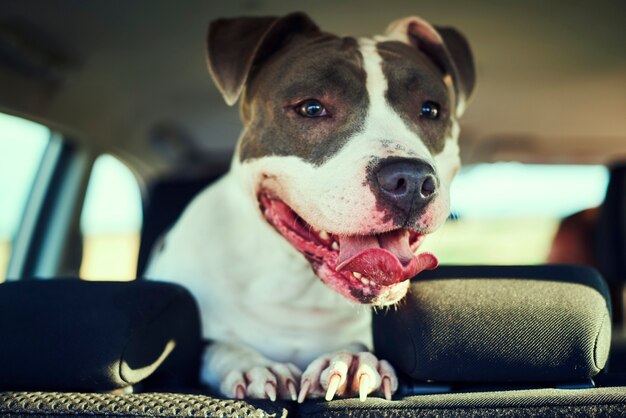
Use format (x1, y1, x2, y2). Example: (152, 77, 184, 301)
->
(207, 13, 319, 106)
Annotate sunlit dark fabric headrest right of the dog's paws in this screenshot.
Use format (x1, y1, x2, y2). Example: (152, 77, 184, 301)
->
(373, 266, 611, 383)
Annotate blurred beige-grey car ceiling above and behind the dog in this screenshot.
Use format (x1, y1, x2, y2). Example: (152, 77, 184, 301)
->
(0, 0, 626, 177)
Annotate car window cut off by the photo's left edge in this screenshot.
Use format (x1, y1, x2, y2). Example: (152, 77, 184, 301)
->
(0, 113, 50, 282)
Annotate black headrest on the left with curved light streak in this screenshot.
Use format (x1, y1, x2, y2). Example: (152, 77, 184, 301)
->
(0, 279, 202, 391)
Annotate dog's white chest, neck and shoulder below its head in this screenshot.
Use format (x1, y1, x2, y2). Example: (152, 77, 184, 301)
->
(147, 175, 371, 367)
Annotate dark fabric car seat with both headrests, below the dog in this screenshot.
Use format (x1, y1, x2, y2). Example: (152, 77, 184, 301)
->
(0, 266, 626, 417)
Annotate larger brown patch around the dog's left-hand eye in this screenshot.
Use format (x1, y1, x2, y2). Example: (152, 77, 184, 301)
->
(239, 35, 369, 165)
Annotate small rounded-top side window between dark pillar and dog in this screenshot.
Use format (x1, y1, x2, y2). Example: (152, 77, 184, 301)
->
(80, 155, 142, 280)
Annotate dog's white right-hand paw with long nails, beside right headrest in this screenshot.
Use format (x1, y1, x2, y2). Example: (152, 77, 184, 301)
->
(298, 352, 398, 403)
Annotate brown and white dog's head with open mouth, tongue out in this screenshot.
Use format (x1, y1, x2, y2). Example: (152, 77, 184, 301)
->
(207, 13, 475, 305)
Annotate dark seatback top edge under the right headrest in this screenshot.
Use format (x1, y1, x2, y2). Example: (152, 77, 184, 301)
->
(299, 387, 626, 418)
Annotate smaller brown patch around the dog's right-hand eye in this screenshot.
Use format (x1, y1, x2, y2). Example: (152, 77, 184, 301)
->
(377, 41, 452, 155)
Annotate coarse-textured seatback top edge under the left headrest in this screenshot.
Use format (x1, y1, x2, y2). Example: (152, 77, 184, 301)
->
(0, 392, 287, 418)
